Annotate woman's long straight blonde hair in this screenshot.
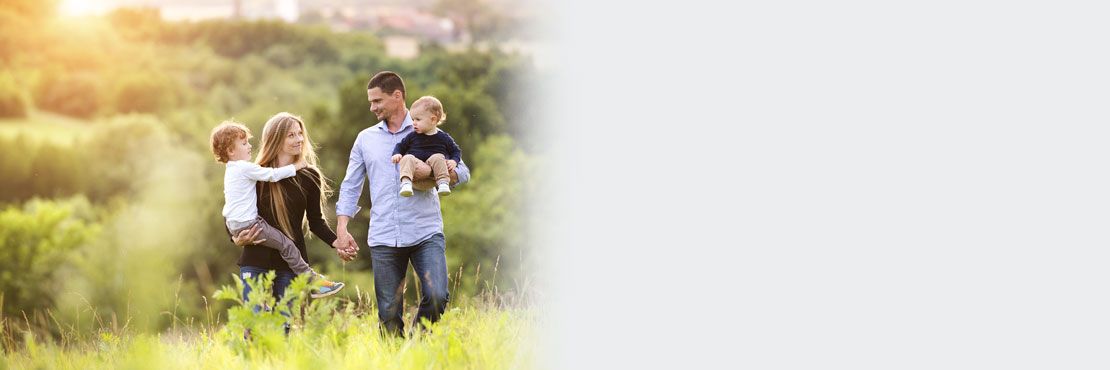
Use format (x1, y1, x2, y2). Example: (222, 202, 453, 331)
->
(254, 112, 332, 239)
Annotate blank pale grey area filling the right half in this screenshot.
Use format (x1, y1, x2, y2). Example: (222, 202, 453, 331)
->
(533, 0, 1110, 369)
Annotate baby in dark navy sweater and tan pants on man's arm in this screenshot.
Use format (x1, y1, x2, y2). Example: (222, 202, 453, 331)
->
(391, 97, 463, 197)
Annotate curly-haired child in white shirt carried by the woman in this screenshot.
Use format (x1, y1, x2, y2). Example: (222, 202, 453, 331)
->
(212, 121, 343, 298)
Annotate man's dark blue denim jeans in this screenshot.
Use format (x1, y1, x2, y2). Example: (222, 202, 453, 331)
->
(370, 233, 451, 334)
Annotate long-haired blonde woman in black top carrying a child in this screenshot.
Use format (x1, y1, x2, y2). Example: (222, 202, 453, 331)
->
(232, 112, 350, 308)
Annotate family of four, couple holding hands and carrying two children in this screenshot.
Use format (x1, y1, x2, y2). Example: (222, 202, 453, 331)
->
(211, 71, 470, 336)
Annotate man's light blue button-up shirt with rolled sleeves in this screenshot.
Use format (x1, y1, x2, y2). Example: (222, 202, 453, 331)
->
(335, 113, 471, 247)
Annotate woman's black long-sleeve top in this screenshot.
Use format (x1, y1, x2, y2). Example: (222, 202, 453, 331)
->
(238, 168, 336, 271)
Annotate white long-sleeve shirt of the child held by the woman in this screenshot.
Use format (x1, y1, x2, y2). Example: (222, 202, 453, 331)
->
(223, 160, 296, 222)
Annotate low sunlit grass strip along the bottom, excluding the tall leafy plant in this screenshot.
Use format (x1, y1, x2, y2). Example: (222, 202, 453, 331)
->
(6, 309, 535, 369)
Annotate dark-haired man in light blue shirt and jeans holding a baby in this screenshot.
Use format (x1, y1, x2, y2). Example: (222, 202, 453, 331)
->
(335, 71, 471, 334)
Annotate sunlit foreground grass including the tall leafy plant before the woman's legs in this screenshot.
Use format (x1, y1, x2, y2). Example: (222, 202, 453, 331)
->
(3, 270, 538, 370)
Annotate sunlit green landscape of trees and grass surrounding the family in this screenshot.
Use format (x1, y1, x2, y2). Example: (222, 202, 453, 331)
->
(0, 0, 543, 369)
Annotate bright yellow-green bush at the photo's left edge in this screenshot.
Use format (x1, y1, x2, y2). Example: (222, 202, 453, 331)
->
(0, 198, 99, 316)
